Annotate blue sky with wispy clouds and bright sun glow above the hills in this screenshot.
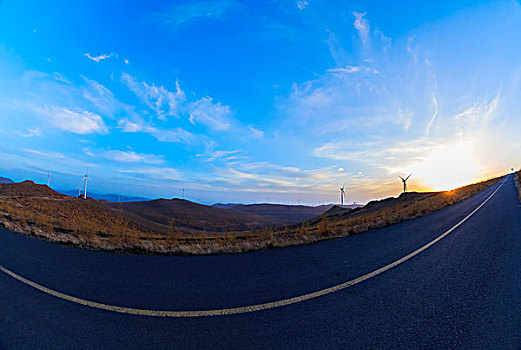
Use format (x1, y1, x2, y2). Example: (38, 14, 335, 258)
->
(0, 0, 521, 205)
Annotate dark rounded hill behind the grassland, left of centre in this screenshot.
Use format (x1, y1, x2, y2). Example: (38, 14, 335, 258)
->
(107, 198, 284, 232)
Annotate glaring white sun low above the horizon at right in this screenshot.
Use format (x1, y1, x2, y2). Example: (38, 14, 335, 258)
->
(411, 141, 484, 191)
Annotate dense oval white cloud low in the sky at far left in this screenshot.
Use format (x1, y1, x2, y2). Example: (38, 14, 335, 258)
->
(35, 106, 107, 134)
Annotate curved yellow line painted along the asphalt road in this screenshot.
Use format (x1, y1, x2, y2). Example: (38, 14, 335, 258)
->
(0, 178, 506, 317)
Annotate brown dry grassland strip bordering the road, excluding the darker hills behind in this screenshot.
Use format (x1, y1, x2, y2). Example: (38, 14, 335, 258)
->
(0, 173, 504, 255)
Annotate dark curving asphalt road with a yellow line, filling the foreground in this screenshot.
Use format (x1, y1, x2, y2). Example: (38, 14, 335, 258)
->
(0, 175, 521, 349)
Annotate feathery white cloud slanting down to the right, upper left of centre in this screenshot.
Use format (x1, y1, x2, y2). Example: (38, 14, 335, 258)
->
(121, 73, 186, 120)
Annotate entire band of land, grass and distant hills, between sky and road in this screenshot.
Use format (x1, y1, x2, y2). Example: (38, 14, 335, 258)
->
(0, 177, 504, 254)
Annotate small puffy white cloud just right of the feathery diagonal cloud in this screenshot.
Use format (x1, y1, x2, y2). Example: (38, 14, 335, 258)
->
(189, 96, 232, 130)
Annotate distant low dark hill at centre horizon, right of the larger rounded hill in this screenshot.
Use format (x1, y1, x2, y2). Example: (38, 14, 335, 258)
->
(214, 203, 332, 225)
